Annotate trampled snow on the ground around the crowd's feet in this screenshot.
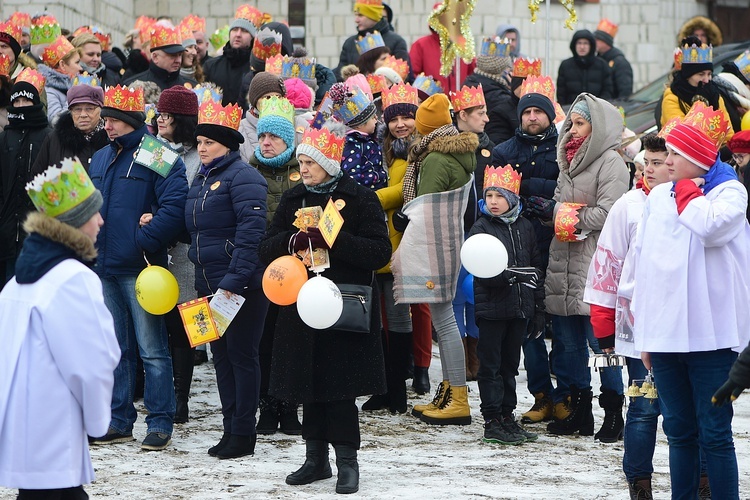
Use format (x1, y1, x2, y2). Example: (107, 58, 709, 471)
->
(0, 346, 750, 500)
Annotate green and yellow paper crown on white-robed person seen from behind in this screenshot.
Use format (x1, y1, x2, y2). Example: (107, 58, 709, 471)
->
(26, 158, 96, 217)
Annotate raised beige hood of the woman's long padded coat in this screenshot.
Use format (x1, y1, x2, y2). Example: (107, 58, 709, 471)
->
(557, 92, 624, 176)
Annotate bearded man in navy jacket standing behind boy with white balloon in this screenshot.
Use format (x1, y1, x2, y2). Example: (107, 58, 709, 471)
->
(492, 93, 560, 422)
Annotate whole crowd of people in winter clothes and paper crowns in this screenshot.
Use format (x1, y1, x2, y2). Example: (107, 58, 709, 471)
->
(0, 0, 750, 499)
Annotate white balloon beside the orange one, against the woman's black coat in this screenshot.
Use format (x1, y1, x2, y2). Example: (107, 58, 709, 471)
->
(297, 276, 344, 330)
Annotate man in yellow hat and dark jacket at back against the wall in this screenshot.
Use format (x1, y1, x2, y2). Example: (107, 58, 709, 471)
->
(333, 0, 411, 82)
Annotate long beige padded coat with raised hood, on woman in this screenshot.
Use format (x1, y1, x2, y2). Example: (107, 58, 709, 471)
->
(545, 94, 629, 316)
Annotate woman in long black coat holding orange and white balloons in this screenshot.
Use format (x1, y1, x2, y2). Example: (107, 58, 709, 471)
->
(260, 123, 391, 493)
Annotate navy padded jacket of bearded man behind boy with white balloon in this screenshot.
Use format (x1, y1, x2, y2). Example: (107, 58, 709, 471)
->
(492, 125, 560, 269)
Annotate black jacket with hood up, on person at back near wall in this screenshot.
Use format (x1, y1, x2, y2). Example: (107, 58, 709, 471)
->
(557, 30, 613, 106)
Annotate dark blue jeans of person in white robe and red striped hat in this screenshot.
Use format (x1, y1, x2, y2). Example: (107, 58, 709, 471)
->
(651, 349, 739, 500)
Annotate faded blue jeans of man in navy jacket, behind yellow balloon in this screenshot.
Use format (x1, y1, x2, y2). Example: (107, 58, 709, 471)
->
(102, 276, 175, 435)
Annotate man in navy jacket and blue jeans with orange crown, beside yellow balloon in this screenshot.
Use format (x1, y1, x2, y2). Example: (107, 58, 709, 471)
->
(89, 89, 188, 450)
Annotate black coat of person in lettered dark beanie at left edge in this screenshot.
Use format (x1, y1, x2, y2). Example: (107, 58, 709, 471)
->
(0, 122, 51, 261)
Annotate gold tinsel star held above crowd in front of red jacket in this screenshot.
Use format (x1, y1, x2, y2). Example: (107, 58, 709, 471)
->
(427, 0, 476, 76)
